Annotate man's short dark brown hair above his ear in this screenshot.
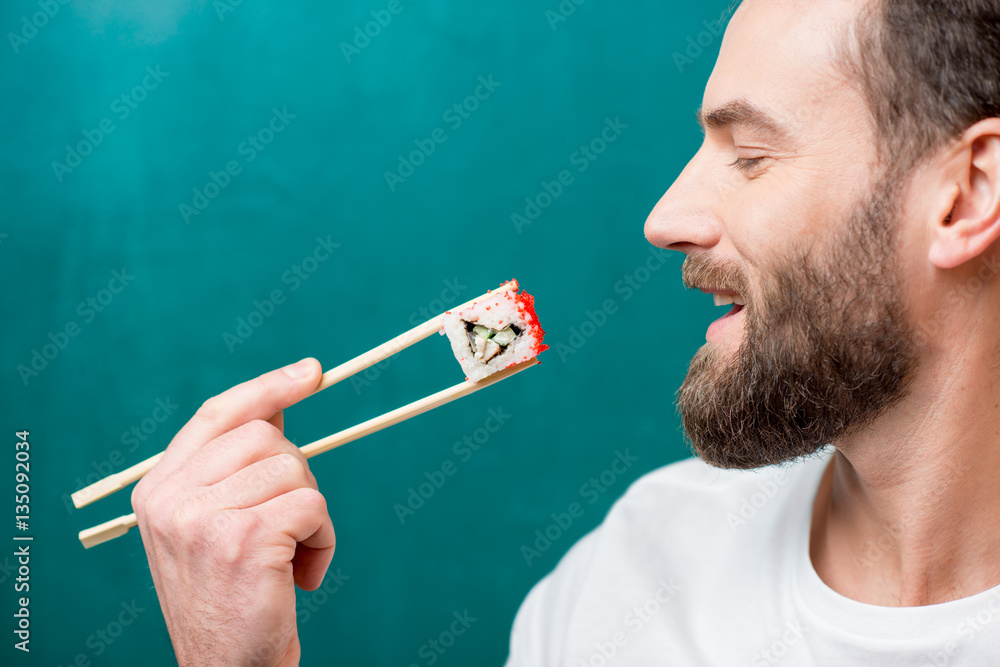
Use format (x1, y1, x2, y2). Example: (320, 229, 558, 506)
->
(844, 0, 1000, 176)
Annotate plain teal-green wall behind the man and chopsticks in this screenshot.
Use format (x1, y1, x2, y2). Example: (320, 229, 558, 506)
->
(0, 0, 728, 665)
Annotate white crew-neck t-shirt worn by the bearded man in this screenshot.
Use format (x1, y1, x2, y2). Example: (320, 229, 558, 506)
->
(507, 448, 1000, 667)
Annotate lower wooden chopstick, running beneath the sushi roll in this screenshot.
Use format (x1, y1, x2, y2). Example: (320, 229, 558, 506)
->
(80, 357, 538, 549)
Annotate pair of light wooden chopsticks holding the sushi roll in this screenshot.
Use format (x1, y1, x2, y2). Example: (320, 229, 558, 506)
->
(71, 282, 538, 549)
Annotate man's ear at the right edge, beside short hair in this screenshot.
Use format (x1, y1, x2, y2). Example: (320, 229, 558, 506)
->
(928, 118, 1000, 269)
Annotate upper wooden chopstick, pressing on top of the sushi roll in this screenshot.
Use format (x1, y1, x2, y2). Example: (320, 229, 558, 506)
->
(70, 281, 514, 508)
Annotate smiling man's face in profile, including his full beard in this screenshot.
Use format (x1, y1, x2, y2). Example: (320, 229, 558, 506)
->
(646, 0, 915, 468)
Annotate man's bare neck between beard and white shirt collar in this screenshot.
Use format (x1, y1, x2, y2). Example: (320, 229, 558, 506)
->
(810, 355, 1000, 606)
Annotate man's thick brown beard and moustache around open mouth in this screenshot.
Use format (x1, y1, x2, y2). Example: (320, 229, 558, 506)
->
(677, 181, 916, 468)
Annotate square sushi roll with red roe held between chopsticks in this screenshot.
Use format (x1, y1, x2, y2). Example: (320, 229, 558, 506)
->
(441, 280, 549, 382)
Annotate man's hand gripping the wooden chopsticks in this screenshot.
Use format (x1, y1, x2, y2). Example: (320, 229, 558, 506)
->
(132, 359, 335, 667)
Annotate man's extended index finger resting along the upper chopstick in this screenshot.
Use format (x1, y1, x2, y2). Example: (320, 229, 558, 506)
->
(147, 358, 322, 486)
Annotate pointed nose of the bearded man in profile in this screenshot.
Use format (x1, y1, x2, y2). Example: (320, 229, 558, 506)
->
(645, 151, 722, 254)
